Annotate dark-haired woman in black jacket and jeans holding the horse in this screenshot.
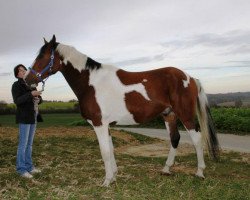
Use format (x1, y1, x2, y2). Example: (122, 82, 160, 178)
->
(12, 64, 42, 178)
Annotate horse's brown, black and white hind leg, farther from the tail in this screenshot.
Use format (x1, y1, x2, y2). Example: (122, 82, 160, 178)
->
(162, 112, 180, 174)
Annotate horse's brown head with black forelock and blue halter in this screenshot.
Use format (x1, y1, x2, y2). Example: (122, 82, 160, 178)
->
(25, 35, 62, 85)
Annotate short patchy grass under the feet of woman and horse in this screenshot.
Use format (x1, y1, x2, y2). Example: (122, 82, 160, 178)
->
(0, 127, 250, 200)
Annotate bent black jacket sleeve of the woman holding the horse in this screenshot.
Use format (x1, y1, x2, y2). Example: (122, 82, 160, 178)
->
(11, 83, 33, 106)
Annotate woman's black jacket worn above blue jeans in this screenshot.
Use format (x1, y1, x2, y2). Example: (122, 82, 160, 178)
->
(11, 78, 42, 124)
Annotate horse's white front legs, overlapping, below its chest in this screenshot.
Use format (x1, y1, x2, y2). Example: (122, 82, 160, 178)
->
(94, 124, 117, 187)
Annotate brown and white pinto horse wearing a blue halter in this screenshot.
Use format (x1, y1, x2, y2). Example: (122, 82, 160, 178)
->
(25, 35, 220, 186)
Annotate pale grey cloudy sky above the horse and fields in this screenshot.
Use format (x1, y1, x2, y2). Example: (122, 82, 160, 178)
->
(0, 0, 250, 103)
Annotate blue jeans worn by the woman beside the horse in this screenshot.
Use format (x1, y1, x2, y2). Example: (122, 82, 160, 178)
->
(16, 124, 36, 175)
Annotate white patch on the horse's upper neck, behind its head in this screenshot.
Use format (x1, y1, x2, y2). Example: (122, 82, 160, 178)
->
(56, 44, 88, 73)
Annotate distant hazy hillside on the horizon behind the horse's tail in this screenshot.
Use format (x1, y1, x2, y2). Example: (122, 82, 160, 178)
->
(207, 92, 250, 106)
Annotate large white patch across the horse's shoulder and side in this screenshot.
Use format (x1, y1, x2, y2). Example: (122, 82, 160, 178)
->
(89, 65, 150, 125)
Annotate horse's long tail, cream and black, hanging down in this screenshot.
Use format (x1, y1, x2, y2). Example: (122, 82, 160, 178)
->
(195, 79, 220, 160)
